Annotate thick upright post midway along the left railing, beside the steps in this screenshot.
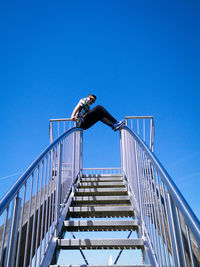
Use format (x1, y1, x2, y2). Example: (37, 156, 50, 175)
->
(55, 142, 62, 236)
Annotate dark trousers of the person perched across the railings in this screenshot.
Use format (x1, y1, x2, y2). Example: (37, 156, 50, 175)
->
(80, 105, 117, 130)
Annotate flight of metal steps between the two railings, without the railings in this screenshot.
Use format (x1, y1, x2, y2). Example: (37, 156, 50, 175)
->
(50, 175, 151, 267)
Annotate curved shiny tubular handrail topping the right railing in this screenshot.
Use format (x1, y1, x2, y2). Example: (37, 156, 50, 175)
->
(121, 126, 200, 243)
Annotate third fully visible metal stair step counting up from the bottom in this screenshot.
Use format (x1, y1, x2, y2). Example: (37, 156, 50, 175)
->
(68, 206, 134, 218)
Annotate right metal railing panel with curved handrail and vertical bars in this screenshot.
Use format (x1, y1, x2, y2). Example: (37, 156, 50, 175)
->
(120, 126, 200, 267)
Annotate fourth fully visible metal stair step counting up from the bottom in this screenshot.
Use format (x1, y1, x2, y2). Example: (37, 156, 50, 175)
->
(72, 196, 130, 204)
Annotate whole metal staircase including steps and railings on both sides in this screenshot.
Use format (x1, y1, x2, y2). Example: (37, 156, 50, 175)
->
(0, 116, 200, 267)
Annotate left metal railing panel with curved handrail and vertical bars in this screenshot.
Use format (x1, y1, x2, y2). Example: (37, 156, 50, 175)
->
(0, 128, 82, 267)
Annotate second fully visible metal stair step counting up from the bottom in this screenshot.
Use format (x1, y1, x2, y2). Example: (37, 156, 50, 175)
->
(63, 220, 138, 232)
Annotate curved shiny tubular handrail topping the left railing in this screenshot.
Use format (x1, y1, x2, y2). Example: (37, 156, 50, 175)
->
(0, 127, 82, 215)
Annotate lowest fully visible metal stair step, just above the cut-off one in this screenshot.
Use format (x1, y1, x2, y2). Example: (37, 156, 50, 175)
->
(57, 238, 144, 249)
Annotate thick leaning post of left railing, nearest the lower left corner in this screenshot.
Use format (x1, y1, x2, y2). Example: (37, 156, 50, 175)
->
(4, 196, 21, 267)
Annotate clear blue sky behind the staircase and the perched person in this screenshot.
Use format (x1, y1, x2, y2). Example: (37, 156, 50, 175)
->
(0, 0, 200, 249)
